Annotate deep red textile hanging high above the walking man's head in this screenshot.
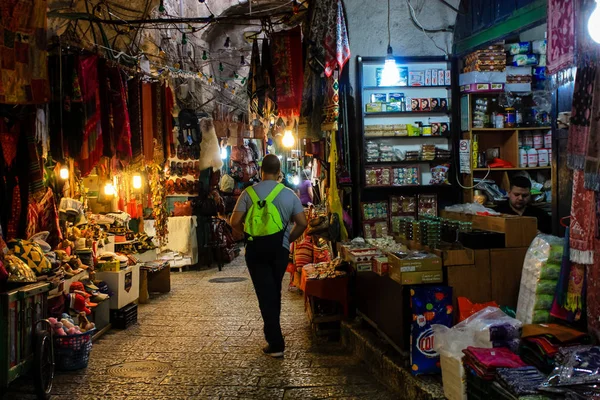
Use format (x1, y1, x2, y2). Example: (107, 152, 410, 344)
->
(272, 27, 303, 117)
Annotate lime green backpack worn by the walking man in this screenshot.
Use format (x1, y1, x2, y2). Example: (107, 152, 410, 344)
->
(244, 183, 285, 240)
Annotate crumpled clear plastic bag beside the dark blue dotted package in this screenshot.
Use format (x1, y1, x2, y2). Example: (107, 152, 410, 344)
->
(431, 307, 523, 357)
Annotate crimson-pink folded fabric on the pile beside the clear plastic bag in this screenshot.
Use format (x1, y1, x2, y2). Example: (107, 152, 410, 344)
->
(463, 346, 526, 380)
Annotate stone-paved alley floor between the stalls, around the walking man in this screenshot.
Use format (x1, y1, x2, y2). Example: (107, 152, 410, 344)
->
(2, 257, 395, 400)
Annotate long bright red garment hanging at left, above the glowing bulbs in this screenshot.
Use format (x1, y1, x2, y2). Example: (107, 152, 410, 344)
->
(74, 56, 104, 177)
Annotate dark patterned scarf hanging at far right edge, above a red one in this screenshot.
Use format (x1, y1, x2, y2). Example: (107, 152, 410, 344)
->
(567, 65, 596, 170)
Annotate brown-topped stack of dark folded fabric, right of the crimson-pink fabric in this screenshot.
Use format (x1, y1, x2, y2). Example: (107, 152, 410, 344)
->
(519, 324, 590, 373)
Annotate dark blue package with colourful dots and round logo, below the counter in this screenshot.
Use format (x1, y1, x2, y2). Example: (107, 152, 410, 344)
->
(410, 286, 454, 375)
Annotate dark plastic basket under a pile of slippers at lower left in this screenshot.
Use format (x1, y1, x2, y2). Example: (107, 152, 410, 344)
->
(54, 329, 95, 371)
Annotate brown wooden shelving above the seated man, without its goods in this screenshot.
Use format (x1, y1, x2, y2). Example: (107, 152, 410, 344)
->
(460, 93, 555, 203)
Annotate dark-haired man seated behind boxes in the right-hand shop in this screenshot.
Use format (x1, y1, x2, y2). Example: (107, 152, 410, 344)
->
(496, 176, 552, 234)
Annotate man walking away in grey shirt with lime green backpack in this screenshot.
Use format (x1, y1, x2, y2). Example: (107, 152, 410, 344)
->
(231, 154, 307, 358)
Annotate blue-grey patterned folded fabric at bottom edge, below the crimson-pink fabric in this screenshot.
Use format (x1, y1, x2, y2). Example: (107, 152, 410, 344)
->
(492, 366, 546, 399)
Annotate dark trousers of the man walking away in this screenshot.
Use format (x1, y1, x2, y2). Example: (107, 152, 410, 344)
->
(246, 240, 290, 351)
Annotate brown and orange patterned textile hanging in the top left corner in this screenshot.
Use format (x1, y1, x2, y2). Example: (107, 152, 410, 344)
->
(0, 0, 50, 104)
